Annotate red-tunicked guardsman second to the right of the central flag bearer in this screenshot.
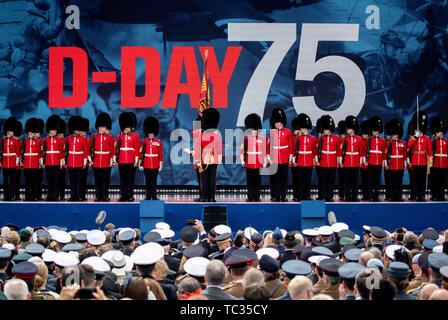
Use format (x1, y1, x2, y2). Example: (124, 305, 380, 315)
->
(269, 108, 294, 202)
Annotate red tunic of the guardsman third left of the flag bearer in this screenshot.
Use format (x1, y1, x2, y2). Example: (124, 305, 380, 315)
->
(89, 133, 115, 168)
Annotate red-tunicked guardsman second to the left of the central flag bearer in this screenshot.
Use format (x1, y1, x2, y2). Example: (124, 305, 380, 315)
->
(115, 112, 140, 202)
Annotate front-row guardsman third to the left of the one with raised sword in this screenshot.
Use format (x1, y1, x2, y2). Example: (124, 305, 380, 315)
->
(341, 116, 365, 201)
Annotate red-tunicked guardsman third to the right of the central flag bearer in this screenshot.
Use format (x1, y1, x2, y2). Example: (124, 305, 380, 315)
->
(293, 113, 317, 201)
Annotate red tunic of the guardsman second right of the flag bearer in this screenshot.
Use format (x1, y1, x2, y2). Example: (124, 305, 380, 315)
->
(270, 128, 294, 164)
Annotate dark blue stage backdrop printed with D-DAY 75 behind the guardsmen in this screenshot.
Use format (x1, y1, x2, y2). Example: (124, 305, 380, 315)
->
(0, 0, 448, 185)
